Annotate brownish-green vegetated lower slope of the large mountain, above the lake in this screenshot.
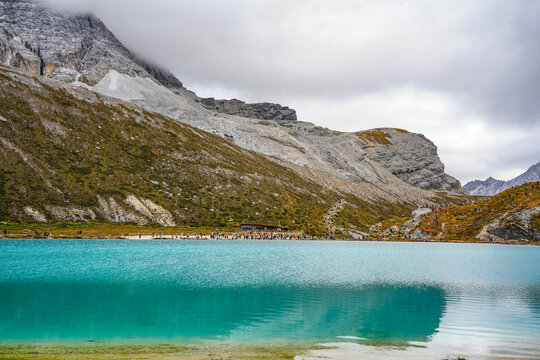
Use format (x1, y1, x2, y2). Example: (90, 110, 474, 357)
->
(0, 66, 438, 235)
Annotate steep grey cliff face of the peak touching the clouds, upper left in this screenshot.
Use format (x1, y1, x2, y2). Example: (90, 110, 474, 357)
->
(0, 0, 182, 88)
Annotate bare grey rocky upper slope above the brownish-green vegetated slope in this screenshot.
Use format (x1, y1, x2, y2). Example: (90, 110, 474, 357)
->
(0, 0, 461, 197)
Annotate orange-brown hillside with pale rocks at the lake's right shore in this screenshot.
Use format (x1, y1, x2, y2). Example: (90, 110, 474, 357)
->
(373, 182, 540, 242)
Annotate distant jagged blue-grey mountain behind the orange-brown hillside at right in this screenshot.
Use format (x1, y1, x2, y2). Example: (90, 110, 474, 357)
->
(463, 163, 540, 196)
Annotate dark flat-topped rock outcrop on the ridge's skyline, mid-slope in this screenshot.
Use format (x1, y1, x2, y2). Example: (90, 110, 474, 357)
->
(200, 98, 297, 121)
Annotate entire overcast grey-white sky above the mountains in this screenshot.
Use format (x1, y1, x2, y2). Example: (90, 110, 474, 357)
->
(46, 0, 540, 182)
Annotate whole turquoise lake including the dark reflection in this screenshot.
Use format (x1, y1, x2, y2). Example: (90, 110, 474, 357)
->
(0, 240, 540, 358)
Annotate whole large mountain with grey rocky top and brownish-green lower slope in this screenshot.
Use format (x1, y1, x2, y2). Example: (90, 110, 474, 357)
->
(0, 0, 463, 232)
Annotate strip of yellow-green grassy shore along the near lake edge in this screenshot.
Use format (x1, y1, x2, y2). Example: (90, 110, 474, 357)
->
(0, 344, 321, 360)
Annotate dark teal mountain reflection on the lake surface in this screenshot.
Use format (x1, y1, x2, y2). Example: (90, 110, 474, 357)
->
(0, 282, 445, 342)
